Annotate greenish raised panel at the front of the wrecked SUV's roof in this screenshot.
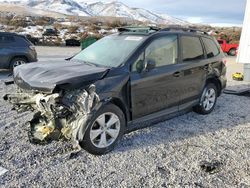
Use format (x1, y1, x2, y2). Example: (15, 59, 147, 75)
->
(117, 26, 161, 33)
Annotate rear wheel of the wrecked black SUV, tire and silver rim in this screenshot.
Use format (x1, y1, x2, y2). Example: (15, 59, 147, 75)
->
(194, 83, 218, 115)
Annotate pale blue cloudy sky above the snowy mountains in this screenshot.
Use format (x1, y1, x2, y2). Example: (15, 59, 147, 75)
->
(96, 0, 246, 26)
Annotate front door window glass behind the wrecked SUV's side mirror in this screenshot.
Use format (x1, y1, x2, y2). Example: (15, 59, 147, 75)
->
(132, 35, 178, 71)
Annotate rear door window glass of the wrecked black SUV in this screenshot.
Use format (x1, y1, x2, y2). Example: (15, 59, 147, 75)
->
(181, 36, 204, 61)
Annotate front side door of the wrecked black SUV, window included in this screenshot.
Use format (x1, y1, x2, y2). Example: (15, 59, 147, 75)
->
(130, 35, 181, 119)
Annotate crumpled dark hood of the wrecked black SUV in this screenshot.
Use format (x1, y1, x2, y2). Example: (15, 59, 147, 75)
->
(14, 61, 108, 93)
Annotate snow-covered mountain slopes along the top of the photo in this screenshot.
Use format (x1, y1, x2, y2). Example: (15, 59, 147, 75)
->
(0, 0, 189, 25)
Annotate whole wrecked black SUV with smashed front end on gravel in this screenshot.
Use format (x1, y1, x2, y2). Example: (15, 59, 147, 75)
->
(4, 27, 226, 154)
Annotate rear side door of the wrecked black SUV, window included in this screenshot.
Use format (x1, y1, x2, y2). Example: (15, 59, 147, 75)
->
(180, 35, 209, 108)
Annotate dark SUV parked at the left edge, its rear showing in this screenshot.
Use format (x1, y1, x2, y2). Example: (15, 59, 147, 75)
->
(0, 32, 37, 69)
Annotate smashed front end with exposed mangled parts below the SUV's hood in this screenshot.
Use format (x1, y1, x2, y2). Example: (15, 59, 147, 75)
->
(4, 84, 100, 146)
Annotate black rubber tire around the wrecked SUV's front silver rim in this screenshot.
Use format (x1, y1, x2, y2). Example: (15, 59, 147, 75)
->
(80, 104, 126, 155)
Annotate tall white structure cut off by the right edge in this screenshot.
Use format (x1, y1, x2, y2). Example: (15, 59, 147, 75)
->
(237, 0, 250, 82)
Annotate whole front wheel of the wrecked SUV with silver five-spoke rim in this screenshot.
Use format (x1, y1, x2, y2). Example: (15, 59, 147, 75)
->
(80, 104, 125, 155)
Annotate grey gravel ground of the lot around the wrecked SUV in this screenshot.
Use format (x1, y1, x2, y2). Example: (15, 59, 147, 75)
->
(0, 48, 250, 188)
